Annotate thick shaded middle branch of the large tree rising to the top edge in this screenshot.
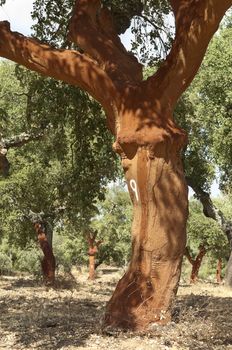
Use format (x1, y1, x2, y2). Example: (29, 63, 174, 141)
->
(69, 0, 142, 82)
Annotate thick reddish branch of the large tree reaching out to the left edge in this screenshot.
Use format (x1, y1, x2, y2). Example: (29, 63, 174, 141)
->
(0, 21, 115, 130)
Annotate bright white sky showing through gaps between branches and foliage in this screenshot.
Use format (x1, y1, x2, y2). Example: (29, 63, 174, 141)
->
(0, 0, 220, 197)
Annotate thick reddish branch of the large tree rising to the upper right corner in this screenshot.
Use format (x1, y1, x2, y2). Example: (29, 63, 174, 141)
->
(148, 0, 232, 109)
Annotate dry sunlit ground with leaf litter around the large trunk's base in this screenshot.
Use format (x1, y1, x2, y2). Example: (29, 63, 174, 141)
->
(0, 268, 232, 350)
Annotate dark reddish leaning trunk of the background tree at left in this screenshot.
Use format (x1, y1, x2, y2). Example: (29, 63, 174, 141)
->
(34, 222, 56, 285)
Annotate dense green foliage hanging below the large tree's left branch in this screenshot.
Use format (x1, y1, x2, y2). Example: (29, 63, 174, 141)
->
(0, 63, 118, 271)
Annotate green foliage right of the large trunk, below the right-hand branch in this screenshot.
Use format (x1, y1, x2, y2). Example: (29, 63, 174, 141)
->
(175, 23, 232, 191)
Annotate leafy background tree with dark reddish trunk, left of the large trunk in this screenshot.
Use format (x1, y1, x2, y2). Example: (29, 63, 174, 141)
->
(1, 63, 116, 280)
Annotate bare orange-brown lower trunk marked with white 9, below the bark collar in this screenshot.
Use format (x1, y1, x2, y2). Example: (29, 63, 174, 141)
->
(105, 142, 188, 329)
